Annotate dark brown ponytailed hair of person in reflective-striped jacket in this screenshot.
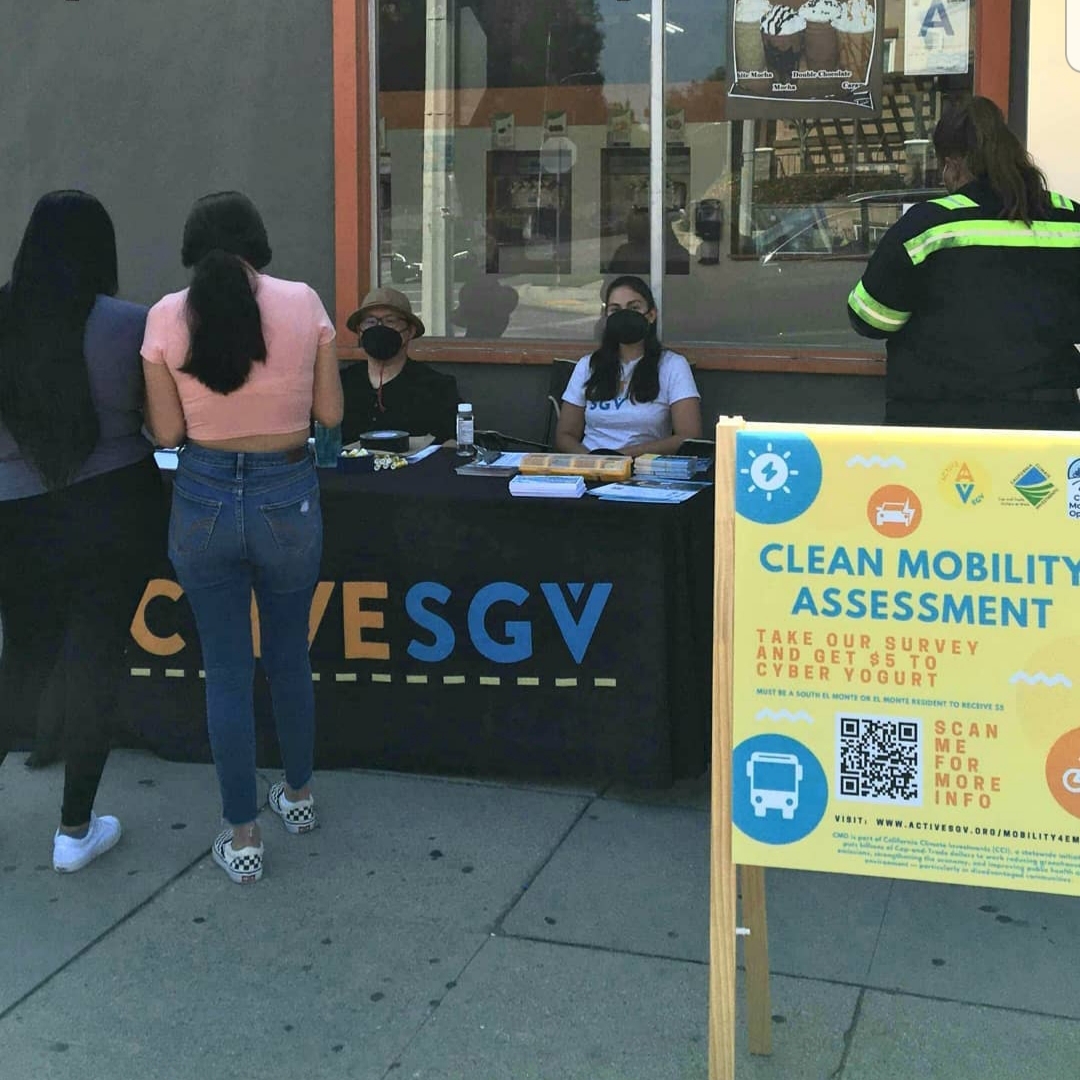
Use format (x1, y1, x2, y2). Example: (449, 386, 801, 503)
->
(934, 97, 1050, 225)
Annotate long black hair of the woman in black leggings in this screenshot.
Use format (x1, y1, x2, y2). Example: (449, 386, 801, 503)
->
(0, 191, 117, 489)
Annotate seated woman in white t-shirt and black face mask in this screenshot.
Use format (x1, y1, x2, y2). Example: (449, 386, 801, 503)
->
(555, 274, 701, 458)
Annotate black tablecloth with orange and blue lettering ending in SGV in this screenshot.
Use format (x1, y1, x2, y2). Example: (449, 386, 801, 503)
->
(118, 450, 713, 784)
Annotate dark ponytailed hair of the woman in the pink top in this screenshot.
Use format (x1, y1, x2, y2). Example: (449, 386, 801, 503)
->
(180, 191, 271, 394)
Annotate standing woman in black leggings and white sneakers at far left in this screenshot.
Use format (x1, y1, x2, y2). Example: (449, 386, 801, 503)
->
(0, 191, 164, 872)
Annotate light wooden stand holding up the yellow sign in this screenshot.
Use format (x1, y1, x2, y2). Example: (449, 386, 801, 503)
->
(708, 417, 772, 1080)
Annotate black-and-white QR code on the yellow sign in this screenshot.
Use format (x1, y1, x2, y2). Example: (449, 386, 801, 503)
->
(836, 713, 922, 806)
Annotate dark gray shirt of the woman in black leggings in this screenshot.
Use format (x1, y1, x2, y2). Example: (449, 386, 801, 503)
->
(0, 296, 153, 500)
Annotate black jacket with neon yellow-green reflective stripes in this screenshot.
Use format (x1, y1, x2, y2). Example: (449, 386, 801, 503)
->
(848, 180, 1080, 430)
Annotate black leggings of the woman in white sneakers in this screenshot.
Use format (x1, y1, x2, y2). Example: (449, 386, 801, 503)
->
(0, 458, 167, 827)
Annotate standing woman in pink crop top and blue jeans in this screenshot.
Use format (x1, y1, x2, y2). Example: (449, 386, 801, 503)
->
(143, 191, 343, 882)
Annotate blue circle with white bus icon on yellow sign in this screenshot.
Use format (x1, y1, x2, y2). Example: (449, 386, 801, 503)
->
(731, 734, 828, 843)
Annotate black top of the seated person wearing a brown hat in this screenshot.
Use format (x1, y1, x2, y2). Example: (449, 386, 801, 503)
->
(341, 360, 460, 443)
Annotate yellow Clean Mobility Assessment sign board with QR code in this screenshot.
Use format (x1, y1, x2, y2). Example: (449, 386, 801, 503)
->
(717, 424, 1080, 895)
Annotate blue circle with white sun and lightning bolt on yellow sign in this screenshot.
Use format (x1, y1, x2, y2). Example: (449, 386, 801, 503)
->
(735, 431, 821, 525)
